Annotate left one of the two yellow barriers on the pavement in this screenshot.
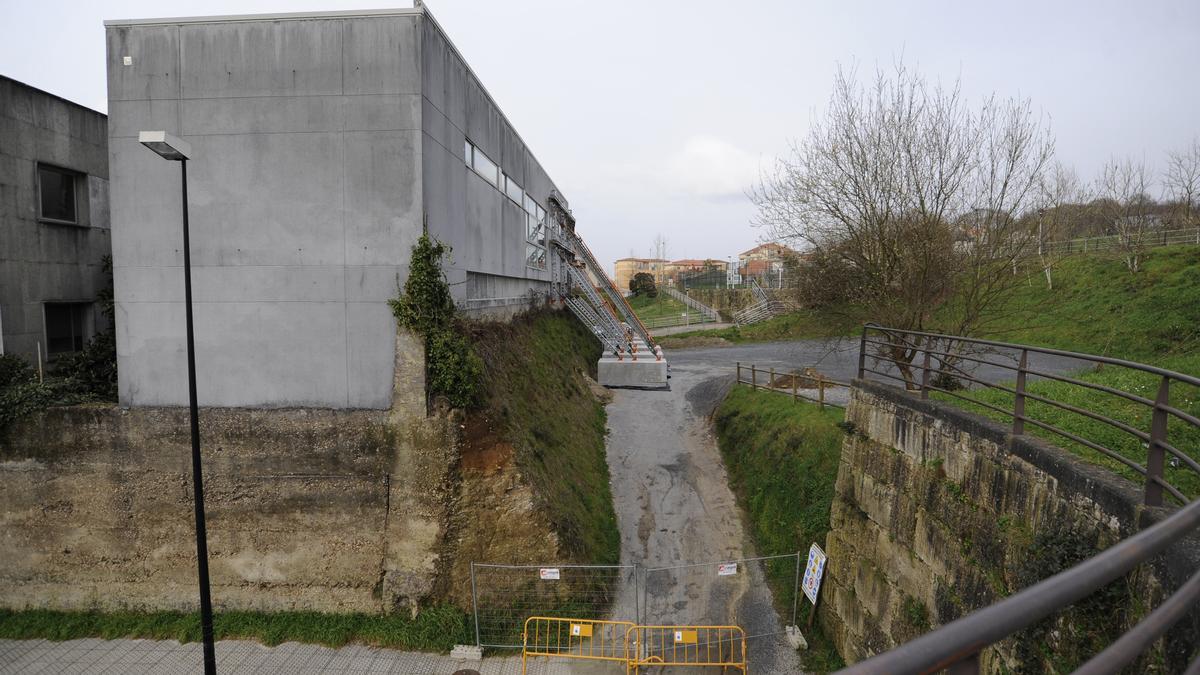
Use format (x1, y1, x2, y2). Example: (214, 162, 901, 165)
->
(521, 616, 634, 675)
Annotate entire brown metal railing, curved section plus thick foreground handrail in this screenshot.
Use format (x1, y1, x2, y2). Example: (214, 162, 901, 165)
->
(839, 324, 1200, 675)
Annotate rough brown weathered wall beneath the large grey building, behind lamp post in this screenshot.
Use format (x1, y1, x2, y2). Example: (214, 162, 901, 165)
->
(0, 324, 460, 613)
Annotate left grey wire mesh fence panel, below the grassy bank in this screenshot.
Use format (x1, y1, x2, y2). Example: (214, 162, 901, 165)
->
(470, 562, 640, 649)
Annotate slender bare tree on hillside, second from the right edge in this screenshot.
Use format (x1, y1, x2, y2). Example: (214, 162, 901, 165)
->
(1096, 157, 1158, 274)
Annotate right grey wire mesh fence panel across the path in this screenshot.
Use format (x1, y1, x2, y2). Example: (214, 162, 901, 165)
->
(640, 552, 803, 638)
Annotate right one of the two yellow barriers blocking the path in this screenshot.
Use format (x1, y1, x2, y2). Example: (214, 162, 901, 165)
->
(626, 626, 746, 674)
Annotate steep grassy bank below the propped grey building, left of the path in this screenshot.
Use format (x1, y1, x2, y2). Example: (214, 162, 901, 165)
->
(467, 310, 620, 563)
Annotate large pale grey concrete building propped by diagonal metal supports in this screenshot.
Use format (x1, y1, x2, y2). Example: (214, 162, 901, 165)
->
(106, 4, 569, 408)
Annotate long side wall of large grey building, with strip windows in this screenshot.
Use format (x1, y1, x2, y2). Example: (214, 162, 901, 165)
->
(421, 14, 554, 313)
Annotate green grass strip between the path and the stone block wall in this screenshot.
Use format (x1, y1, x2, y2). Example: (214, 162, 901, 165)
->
(714, 387, 845, 671)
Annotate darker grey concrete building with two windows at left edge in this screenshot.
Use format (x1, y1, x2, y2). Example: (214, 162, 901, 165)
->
(0, 76, 110, 363)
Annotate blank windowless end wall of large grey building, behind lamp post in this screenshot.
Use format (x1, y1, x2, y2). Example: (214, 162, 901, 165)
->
(107, 12, 422, 408)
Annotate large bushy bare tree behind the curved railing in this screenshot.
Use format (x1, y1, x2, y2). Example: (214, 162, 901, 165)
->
(750, 65, 1054, 383)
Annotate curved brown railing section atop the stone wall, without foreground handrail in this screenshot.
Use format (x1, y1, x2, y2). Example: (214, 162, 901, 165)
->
(858, 324, 1200, 506)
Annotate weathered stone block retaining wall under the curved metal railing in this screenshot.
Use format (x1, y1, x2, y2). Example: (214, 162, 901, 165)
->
(821, 382, 1200, 671)
